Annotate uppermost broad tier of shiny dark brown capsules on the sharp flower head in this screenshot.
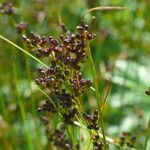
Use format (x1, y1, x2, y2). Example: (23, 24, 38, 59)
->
(23, 22, 94, 70)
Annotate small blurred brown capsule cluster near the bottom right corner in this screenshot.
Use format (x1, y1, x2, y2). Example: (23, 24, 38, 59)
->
(119, 132, 136, 148)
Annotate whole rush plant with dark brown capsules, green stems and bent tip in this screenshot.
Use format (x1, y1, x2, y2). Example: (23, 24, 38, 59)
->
(0, 2, 149, 150)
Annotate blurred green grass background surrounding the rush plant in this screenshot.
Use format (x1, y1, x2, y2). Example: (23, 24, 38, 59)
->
(0, 0, 150, 150)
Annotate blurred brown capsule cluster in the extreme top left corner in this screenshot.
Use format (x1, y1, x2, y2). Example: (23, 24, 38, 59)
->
(0, 2, 15, 15)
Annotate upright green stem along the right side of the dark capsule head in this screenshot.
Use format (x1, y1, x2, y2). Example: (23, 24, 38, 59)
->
(87, 43, 107, 150)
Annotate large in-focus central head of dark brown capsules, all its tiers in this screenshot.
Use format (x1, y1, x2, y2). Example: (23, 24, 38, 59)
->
(23, 22, 94, 124)
